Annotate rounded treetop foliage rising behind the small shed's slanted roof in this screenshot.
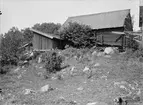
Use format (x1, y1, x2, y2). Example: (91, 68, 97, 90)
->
(32, 23, 61, 34)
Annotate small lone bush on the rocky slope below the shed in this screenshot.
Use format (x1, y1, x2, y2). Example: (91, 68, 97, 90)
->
(44, 51, 63, 74)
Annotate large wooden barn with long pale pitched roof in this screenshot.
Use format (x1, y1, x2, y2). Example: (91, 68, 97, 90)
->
(62, 9, 133, 47)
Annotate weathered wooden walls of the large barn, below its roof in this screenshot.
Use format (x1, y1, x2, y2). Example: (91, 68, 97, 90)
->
(97, 14, 133, 47)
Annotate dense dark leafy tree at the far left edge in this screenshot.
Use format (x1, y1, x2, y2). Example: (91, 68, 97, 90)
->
(0, 27, 23, 66)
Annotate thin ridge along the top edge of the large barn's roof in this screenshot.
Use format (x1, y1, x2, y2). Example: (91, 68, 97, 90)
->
(68, 9, 130, 18)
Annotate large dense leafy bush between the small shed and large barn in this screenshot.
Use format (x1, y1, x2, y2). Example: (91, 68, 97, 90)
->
(59, 23, 95, 48)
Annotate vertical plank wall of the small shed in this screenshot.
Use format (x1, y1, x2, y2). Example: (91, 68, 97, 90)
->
(33, 33, 56, 50)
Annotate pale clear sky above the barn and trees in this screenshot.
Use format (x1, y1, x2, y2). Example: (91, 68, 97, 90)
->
(0, 0, 139, 33)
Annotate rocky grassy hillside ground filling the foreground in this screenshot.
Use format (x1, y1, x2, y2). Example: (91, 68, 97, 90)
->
(0, 50, 143, 105)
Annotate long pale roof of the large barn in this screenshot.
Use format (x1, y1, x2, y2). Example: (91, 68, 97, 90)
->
(62, 9, 130, 29)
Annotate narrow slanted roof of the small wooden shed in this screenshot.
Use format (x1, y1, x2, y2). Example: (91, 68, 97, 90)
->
(30, 29, 60, 39)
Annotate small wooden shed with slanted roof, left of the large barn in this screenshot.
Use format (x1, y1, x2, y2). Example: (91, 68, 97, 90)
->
(31, 29, 62, 51)
